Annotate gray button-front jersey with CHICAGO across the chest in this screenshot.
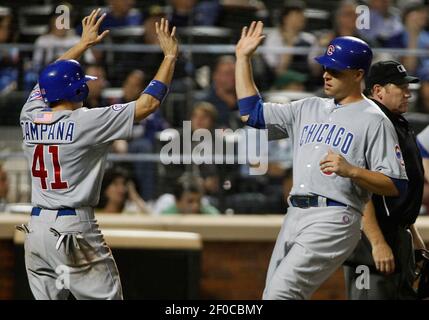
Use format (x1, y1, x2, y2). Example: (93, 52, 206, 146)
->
(263, 97, 407, 211)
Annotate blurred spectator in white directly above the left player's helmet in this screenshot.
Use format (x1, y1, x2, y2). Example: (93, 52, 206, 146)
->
(33, 13, 95, 72)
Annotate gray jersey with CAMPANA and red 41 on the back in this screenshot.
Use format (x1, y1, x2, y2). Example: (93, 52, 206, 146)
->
(20, 85, 135, 209)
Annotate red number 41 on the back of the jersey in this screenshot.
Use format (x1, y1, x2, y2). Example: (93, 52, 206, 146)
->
(31, 144, 68, 190)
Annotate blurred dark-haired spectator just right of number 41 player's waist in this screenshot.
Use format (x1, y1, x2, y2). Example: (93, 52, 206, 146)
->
(97, 167, 150, 214)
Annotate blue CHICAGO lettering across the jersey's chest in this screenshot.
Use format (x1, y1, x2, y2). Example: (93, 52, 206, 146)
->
(299, 123, 354, 154)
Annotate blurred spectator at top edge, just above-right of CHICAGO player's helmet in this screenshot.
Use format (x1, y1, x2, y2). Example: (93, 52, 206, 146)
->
(359, 0, 404, 47)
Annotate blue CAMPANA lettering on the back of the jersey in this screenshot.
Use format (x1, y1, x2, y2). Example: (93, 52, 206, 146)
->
(21, 121, 75, 142)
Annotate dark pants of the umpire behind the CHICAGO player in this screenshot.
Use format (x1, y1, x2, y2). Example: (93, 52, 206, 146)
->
(344, 227, 417, 300)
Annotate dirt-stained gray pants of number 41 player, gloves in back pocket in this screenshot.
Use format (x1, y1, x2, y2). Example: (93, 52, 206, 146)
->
(20, 208, 123, 300)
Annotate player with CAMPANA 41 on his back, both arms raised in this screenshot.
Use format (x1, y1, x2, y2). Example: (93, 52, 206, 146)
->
(19, 9, 178, 299)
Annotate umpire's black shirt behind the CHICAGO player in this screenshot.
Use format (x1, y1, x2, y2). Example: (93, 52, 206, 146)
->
(372, 100, 424, 253)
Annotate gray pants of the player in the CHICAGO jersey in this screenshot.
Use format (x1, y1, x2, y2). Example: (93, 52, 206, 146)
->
(263, 206, 361, 300)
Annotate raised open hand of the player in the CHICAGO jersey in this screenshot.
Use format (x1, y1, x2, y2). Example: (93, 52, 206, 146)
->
(235, 21, 265, 58)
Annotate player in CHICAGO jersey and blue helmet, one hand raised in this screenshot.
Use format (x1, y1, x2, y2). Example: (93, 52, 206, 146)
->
(236, 22, 407, 299)
